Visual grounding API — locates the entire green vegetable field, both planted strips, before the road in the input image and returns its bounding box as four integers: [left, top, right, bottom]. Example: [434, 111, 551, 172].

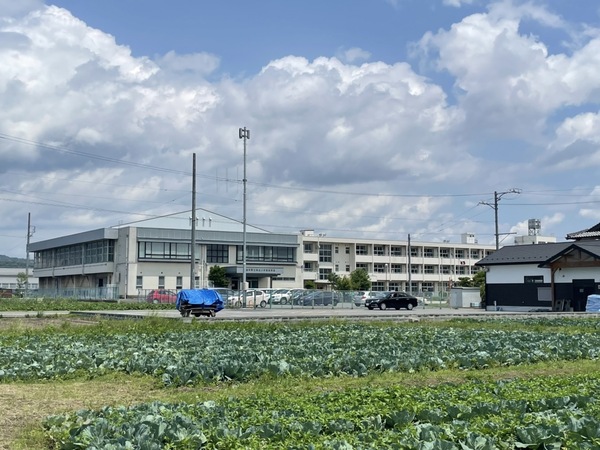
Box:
[0, 318, 600, 450]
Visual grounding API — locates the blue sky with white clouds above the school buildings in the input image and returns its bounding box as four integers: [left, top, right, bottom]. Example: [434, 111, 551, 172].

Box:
[0, 0, 600, 257]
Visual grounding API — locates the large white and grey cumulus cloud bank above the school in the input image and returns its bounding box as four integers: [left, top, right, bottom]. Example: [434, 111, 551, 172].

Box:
[0, 0, 600, 254]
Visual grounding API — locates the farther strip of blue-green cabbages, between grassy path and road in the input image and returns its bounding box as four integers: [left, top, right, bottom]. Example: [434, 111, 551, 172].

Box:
[0, 323, 600, 385]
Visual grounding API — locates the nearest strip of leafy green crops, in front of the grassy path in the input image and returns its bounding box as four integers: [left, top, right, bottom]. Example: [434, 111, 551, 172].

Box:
[44, 375, 600, 450]
